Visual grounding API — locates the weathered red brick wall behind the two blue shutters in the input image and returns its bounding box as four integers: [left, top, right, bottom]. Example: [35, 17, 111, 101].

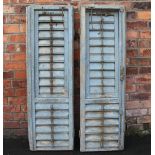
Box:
[3, 0, 151, 136]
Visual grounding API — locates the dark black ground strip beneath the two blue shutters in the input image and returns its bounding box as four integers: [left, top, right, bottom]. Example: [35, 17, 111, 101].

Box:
[3, 135, 151, 155]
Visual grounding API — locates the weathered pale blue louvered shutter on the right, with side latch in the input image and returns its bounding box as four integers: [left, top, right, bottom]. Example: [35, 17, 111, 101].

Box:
[80, 5, 125, 151]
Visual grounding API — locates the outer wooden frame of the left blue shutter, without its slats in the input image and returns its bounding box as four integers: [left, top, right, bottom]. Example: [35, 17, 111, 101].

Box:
[26, 5, 74, 151]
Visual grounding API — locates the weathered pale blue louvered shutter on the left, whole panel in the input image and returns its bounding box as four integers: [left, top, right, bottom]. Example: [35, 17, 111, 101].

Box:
[27, 5, 73, 150]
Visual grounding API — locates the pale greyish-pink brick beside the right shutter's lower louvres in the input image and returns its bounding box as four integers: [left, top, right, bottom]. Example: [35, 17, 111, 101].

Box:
[126, 109, 147, 117]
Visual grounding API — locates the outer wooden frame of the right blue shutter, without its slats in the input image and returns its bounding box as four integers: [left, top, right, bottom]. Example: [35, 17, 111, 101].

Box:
[80, 4, 126, 152]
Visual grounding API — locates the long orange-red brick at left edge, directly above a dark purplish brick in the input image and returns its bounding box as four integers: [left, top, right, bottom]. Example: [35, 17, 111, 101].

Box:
[4, 62, 26, 70]
